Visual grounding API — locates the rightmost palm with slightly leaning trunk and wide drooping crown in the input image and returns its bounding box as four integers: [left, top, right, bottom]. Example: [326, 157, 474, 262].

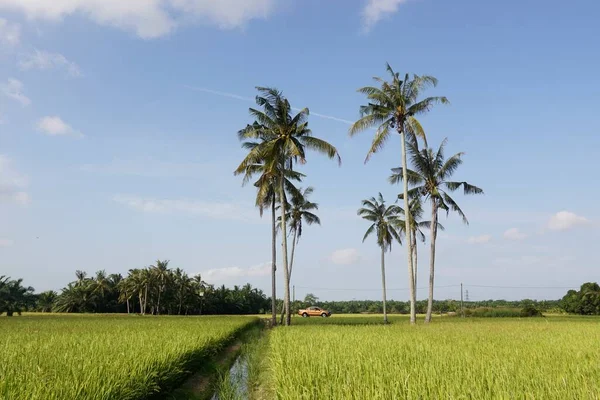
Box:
[390, 139, 483, 322]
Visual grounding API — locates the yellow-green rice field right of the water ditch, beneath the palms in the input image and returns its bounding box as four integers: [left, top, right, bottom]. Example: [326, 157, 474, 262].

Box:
[269, 316, 600, 400]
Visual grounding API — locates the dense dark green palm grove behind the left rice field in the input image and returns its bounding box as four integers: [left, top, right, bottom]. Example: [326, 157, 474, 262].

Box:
[0, 260, 270, 316]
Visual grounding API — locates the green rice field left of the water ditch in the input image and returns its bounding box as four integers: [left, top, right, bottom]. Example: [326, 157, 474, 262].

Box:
[0, 315, 257, 400]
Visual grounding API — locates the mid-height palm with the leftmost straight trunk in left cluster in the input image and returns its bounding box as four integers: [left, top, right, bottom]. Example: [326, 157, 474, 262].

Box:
[234, 155, 304, 326]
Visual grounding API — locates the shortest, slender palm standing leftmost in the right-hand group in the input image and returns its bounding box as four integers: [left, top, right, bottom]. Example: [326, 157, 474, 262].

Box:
[358, 193, 401, 324]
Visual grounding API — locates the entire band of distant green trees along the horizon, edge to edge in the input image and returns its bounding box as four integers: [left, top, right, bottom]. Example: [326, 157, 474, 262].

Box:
[0, 274, 600, 316]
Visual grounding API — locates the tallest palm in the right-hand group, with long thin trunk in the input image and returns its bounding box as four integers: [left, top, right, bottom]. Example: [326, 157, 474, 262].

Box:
[349, 64, 448, 324]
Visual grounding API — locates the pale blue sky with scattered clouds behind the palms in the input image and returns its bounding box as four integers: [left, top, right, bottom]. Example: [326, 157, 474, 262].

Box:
[0, 0, 600, 300]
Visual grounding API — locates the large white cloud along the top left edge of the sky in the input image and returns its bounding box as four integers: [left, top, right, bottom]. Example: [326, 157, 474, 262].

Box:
[0, 0, 276, 39]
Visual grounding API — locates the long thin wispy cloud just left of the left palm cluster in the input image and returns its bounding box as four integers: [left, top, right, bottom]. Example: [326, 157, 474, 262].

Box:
[113, 195, 259, 221]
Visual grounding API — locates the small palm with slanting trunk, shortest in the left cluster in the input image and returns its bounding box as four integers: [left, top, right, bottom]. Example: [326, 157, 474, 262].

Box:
[281, 186, 321, 320]
